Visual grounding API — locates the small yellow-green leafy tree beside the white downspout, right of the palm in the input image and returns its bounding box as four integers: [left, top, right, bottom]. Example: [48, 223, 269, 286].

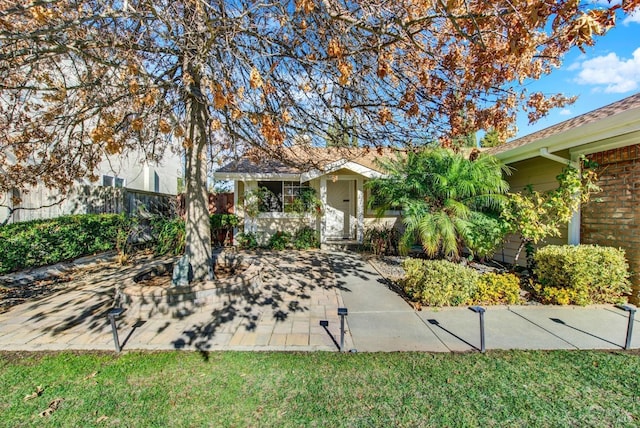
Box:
[502, 166, 600, 264]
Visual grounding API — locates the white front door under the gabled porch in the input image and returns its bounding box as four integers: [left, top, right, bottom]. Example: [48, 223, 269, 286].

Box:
[325, 180, 354, 239]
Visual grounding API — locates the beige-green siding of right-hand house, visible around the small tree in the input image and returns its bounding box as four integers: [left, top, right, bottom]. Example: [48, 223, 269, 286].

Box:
[494, 154, 568, 266]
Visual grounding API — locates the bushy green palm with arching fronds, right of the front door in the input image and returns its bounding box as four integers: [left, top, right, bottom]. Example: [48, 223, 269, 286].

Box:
[369, 148, 509, 259]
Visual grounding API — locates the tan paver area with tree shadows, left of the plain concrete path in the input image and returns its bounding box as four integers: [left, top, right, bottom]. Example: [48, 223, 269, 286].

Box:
[0, 251, 342, 351]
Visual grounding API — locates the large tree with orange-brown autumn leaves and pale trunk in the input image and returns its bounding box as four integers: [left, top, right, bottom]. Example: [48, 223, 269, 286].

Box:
[0, 0, 638, 278]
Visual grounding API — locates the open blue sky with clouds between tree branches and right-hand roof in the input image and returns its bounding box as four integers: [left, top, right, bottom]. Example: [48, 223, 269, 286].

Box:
[517, 5, 640, 137]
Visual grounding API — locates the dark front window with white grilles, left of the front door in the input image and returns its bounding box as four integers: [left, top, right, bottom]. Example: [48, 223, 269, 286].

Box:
[258, 181, 313, 213]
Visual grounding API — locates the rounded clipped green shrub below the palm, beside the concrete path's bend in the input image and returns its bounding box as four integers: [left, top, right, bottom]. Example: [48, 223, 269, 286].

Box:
[400, 259, 479, 306]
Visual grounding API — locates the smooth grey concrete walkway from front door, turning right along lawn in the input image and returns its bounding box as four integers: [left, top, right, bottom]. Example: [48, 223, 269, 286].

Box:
[331, 254, 640, 352]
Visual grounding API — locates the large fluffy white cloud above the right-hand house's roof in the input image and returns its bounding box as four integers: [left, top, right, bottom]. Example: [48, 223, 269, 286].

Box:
[572, 48, 640, 94]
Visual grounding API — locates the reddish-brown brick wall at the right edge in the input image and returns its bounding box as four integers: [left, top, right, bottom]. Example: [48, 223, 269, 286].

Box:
[580, 144, 640, 304]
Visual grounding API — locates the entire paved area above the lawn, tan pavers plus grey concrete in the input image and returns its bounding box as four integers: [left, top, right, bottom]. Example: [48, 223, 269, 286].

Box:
[0, 251, 640, 352]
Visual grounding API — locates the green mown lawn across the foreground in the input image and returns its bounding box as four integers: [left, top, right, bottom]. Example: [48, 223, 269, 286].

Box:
[0, 351, 640, 427]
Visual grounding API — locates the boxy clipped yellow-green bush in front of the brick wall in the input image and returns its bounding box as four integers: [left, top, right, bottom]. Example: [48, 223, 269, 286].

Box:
[534, 245, 631, 305]
